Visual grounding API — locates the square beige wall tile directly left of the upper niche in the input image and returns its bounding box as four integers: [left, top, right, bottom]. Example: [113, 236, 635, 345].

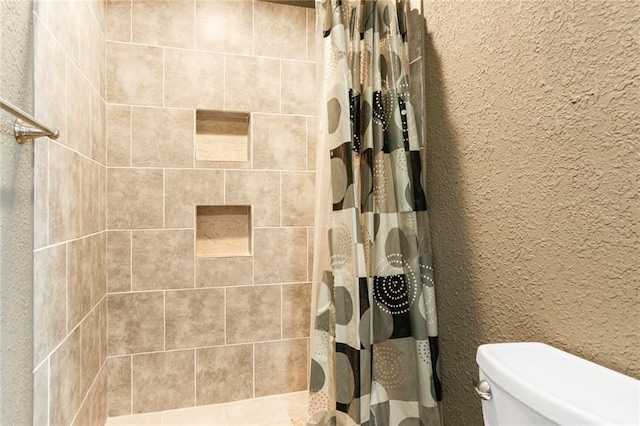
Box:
[131, 107, 194, 167]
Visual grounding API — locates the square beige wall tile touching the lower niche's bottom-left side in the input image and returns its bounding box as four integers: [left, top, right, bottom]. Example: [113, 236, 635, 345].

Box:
[132, 230, 195, 290]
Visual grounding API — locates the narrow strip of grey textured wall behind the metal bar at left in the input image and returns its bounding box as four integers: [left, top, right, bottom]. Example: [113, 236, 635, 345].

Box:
[0, 0, 33, 425]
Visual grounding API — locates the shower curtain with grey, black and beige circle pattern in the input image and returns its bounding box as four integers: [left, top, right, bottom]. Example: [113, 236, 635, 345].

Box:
[307, 0, 441, 426]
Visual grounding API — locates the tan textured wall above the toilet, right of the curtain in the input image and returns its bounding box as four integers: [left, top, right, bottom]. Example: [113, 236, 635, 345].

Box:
[424, 0, 640, 425]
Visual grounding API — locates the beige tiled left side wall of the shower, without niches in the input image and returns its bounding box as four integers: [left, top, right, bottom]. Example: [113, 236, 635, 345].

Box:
[33, 0, 107, 425]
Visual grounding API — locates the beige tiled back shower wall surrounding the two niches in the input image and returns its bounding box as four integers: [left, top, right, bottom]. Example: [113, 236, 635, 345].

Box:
[106, 0, 316, 416]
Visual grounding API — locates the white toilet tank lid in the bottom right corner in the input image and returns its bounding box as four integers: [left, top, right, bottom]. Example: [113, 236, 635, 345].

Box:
[476, 342, 640, 426]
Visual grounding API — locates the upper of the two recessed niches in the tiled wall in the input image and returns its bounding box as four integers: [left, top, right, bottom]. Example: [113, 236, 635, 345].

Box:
[196, 110, 249, 162]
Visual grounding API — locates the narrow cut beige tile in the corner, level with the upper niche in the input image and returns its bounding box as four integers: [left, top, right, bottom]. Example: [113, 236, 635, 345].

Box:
[107, 105, 131, 166]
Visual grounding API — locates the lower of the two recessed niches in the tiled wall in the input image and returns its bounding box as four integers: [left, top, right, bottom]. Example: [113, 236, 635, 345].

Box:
[196, 206, 251, 257]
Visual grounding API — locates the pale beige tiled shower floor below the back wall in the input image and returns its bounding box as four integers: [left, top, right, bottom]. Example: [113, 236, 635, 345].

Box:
[106, 391, 307, 426]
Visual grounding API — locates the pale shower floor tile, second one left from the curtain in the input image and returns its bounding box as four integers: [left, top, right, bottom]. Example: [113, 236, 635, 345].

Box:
[224, 397, 288, 426]
